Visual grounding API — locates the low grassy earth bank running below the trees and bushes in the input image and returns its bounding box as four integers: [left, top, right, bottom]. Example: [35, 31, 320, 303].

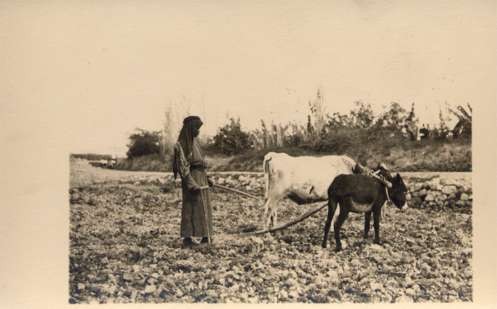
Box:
[110, 140, 472, 172]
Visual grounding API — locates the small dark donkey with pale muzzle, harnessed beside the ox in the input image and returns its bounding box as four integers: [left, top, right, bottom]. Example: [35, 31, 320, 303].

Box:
[322, 169, 407, 251]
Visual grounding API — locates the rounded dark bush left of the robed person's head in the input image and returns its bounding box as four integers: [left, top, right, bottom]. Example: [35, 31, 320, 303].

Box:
[126, 128, 162, 159]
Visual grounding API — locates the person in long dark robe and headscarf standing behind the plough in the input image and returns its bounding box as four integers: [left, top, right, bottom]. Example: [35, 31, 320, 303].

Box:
[173, 116, 212, 248]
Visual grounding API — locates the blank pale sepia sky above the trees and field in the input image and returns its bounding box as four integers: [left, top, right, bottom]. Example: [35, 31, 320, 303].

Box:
[0, 0, 497, 155]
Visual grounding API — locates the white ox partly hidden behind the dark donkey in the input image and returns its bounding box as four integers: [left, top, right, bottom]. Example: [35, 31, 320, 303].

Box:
[263, 152, 356, 228]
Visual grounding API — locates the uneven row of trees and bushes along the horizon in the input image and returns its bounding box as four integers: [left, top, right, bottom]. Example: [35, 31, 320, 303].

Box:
[118, 90, 472, 160]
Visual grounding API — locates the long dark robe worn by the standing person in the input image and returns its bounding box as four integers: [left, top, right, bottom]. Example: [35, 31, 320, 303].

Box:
[174, 138, 212, 237]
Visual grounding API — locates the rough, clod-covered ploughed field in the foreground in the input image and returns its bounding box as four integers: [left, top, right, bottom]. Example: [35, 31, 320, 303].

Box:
[69, 161, 473, 303]
